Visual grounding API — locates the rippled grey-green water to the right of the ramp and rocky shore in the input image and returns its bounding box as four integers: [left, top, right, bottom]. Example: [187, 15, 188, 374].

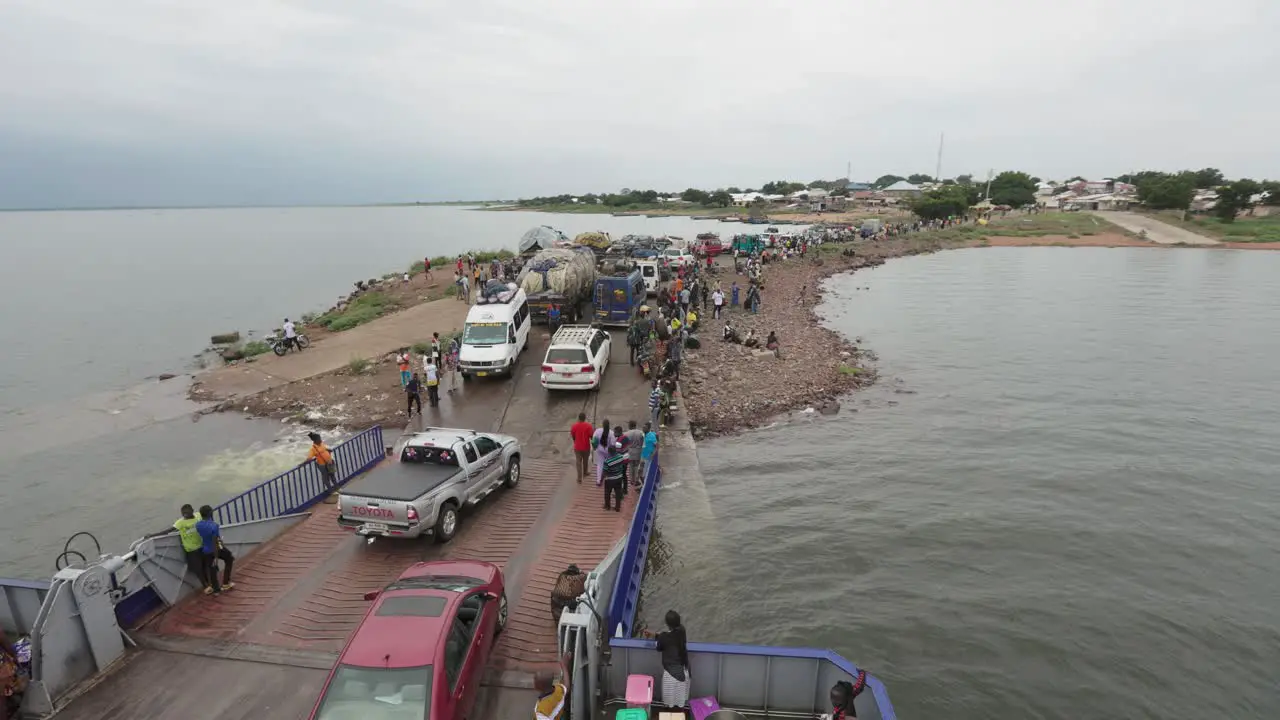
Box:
[643, 247, 1280, 720]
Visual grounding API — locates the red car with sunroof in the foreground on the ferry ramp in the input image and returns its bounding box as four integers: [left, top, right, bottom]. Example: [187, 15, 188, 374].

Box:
[311, 561, 507, 720]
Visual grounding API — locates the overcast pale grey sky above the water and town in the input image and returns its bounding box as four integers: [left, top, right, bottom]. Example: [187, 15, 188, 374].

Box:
[0, 0, 1280, 208]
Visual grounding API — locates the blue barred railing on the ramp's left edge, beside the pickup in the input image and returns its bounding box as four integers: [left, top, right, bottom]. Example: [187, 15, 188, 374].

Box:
[214, 425, 387, 525]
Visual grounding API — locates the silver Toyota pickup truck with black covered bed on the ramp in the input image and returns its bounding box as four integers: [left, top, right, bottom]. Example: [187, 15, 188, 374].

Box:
[338, 428, 521, 542]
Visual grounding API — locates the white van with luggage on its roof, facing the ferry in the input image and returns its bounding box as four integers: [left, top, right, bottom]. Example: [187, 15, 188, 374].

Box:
[458, 283, 530, 380]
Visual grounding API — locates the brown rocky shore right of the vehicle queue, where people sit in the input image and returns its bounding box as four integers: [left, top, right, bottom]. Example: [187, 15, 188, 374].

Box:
[681, 233, 972, 438]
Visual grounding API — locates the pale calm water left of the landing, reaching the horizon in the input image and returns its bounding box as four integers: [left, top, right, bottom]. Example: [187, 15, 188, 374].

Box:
[0, 206, 741, 579]
